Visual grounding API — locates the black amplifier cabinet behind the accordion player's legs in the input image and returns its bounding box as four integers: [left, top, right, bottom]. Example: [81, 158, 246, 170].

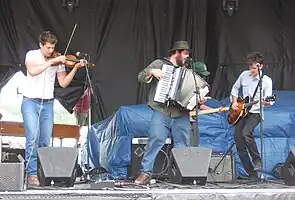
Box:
[128, 138, 172, 180]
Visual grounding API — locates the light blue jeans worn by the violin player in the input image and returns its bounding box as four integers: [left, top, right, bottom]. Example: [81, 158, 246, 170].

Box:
[21, 97, 53, 176]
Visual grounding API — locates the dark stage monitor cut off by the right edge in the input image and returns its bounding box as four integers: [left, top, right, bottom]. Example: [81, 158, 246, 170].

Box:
[282, 148, 295, 186]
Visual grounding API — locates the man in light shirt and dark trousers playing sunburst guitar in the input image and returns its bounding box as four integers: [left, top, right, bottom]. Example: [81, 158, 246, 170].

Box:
[231, 53, 272, 179]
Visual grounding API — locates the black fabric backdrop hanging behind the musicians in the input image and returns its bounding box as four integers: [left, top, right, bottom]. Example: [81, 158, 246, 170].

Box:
[0, 0, 295, 122]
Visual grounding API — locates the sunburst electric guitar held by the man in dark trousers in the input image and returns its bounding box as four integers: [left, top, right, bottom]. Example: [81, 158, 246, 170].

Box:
[227, 95, 276, 125]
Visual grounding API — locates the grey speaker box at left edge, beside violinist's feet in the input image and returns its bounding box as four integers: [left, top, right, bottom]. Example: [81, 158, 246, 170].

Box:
[0, 162, 25, 192]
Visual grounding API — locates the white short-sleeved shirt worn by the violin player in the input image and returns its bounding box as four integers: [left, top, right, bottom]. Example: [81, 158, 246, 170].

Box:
[23, 49, 65, 99]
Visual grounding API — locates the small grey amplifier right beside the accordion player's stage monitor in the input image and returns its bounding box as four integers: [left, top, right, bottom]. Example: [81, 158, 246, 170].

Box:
[207, 152, 236, 183]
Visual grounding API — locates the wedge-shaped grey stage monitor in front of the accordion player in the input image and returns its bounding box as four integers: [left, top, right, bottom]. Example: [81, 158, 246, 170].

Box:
[169, 147, 212, 185]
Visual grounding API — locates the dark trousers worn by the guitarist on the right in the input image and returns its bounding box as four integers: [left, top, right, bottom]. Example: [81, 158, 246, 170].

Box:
[234, 113, 261, 174]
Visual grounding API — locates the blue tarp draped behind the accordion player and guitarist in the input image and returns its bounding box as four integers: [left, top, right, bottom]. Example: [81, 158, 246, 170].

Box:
[82, 91, 295, 179]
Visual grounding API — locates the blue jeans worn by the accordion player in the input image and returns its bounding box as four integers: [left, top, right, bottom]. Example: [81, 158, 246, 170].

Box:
[141, 110, 190, 175]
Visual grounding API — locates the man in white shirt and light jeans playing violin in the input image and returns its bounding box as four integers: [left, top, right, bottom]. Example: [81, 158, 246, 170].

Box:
[21, 31, 85, 187]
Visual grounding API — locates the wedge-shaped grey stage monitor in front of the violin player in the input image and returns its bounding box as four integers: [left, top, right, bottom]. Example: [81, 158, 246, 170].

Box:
[38, 147, 78, 187]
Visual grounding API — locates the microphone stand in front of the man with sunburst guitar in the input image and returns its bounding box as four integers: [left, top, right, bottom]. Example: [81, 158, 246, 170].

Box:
[258, 66, 265, 182]
